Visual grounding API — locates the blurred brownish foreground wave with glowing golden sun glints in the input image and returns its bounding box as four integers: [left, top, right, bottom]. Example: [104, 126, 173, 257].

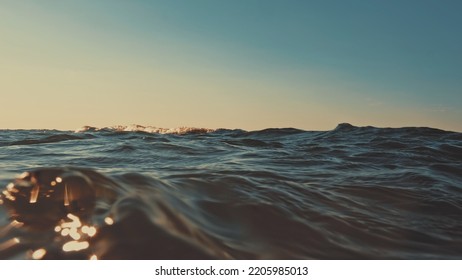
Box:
[0, 167, 220, 259]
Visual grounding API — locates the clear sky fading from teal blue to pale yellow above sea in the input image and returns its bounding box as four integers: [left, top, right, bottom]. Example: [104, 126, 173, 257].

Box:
[0, 0, 462, 131]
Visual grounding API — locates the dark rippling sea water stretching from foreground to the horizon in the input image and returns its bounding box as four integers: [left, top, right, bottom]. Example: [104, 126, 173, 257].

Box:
[0, 124, 462, 259]
